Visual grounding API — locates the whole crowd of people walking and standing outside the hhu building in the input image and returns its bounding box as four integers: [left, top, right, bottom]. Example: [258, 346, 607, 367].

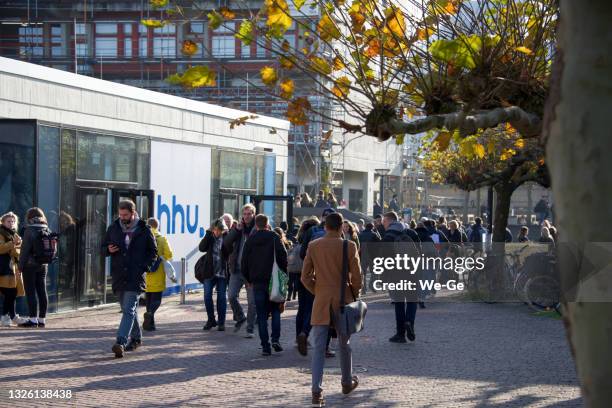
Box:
[0, 197, 557, 404]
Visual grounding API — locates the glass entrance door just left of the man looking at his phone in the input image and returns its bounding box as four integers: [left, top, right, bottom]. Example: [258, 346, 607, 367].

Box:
[76, 188, 108, 307]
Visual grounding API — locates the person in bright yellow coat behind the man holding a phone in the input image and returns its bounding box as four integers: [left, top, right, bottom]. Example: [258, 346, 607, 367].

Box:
[142, 218, 176, 331]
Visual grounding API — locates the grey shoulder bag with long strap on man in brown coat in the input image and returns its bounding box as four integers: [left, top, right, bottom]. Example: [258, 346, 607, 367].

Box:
[334, 240, 368, 337]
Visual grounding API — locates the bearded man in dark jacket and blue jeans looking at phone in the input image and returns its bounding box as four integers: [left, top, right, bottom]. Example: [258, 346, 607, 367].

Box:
[102, 200, 157, 358]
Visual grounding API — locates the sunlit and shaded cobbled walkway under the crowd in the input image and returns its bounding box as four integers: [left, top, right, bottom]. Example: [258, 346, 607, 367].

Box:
[0, 294, 582, 407]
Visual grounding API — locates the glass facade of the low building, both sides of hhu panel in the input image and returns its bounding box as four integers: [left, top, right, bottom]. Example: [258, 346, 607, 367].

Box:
[0, 119, 284, 313]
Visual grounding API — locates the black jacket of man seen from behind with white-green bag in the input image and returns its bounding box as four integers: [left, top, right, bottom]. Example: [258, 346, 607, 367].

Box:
[241, 230, 287, 290]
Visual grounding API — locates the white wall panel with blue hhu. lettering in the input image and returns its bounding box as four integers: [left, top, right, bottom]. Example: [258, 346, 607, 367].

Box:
[151, 141, 211, 292]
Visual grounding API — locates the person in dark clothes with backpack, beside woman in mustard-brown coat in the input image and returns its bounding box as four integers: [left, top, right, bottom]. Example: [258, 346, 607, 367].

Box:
[19, 207, 57, 327]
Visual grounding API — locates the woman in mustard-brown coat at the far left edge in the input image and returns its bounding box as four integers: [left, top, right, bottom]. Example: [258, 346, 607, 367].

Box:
[0, 212, 25, 326]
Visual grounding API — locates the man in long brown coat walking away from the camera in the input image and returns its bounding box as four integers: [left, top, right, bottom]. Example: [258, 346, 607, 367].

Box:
[301, 213, 361, 406]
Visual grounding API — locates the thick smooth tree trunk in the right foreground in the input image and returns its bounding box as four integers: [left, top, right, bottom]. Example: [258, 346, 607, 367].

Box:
[544, 0, 612, 407]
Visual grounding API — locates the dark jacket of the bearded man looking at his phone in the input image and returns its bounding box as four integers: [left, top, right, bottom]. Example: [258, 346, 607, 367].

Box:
[102, 219, 157, 293]
